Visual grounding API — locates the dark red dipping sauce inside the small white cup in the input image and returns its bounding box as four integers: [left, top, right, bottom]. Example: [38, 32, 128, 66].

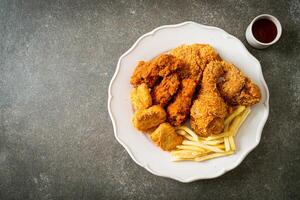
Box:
[252, 19, 277, 43]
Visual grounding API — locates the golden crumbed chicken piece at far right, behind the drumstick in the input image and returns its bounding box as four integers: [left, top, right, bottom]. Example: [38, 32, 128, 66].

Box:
[218, 61, 261, 106]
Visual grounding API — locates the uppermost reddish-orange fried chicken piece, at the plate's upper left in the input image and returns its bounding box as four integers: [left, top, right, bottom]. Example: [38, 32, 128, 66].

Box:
[130, 54, 183, 88]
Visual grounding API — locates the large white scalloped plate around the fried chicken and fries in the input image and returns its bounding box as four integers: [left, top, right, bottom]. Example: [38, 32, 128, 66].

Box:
[108, 22, 269, 182]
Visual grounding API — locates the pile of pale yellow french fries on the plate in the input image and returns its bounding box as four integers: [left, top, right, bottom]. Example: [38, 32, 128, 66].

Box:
[171, 106, 250, 162]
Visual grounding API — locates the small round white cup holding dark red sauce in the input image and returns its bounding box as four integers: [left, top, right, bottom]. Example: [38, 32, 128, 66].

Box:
[246, 14, 282, 49]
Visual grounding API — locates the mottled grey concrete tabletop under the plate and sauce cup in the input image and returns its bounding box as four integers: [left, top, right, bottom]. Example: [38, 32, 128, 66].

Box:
[0, 0, 300, 200]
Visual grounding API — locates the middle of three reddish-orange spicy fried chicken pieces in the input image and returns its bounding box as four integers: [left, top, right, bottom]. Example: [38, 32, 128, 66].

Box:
[151, 73, 180, 107]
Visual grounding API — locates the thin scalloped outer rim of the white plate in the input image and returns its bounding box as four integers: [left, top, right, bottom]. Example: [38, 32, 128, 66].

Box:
[107, 21, 270, 183]
